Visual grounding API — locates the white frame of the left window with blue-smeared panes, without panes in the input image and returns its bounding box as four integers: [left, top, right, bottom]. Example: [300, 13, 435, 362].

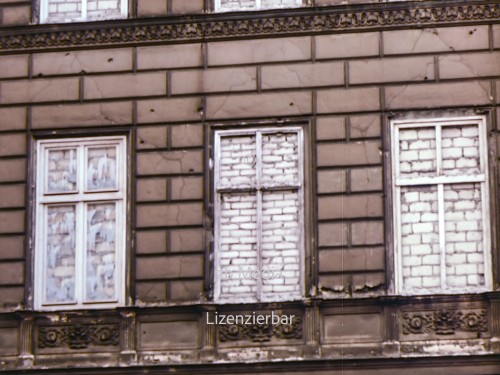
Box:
[33, 136, 127, 311]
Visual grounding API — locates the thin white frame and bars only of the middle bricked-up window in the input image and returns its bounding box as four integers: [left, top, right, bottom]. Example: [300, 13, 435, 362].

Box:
[214, 127, 305, 303]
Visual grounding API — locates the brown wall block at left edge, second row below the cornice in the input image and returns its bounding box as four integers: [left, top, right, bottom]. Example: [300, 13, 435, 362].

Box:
[0, 78, 80, 104]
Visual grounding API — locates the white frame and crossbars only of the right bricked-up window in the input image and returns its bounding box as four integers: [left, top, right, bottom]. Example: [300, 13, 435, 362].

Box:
[391, 116, 493, 295]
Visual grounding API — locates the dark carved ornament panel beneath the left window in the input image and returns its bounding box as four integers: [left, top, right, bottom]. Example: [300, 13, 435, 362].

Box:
[38, 324, 120, 349]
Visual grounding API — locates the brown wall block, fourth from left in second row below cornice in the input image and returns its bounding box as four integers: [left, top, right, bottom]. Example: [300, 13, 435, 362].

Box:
[262, 62, 344, 90]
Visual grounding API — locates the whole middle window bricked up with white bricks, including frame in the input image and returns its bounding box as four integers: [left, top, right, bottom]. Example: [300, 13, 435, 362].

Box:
[214, 128, 304, 302]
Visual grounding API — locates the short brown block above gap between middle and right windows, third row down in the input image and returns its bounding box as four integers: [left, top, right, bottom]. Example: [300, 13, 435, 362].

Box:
[317, 87, 380, 113]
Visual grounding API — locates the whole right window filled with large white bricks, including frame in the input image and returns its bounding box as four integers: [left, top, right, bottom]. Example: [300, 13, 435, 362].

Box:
[392, 117, 492, 294]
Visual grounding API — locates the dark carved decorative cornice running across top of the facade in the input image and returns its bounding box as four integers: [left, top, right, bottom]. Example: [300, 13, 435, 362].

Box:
[0, 0, 500, 52]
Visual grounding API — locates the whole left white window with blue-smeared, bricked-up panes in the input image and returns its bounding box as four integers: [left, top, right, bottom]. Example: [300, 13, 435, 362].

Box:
[34, 136, 127, 310]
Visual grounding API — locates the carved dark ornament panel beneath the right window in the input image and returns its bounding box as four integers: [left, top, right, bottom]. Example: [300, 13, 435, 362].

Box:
[402, 310, 488, 335]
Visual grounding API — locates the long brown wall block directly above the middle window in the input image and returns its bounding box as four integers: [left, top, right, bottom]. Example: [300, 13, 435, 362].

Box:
[207, 92, 312, 119]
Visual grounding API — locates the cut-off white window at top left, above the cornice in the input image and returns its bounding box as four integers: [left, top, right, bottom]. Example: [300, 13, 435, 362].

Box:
[40, 0, 128, 23]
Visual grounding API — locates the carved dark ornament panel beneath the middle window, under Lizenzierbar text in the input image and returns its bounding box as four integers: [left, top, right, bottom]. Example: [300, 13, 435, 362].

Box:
[217, 317, 302, 342]
